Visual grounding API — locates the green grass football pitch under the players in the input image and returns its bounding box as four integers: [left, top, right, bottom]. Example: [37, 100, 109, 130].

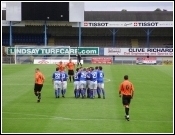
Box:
[1, 64, 174, 133]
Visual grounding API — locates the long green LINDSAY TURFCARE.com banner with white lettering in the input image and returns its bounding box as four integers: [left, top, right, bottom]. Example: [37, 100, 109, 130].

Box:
[7, 46, 99, 55]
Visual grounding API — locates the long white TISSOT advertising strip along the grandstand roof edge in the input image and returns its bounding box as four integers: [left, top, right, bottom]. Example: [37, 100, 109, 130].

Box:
[76, 21, 173, 28]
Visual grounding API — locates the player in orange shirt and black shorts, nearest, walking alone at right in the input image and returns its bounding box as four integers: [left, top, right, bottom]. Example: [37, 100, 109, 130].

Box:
[119, 75, 134, 121]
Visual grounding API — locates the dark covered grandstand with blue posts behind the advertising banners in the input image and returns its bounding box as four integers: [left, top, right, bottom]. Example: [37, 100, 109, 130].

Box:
[2, 2, 173, 64]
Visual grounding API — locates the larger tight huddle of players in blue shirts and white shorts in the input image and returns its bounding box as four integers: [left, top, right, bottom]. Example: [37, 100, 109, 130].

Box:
[74, 66, 105, 99]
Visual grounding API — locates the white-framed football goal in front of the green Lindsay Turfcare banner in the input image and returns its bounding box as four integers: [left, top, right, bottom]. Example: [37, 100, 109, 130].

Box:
[11, 45, 70, 64]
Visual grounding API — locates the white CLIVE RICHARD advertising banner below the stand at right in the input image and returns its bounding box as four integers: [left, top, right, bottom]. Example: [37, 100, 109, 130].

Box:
[104, 48, 173, 56]
